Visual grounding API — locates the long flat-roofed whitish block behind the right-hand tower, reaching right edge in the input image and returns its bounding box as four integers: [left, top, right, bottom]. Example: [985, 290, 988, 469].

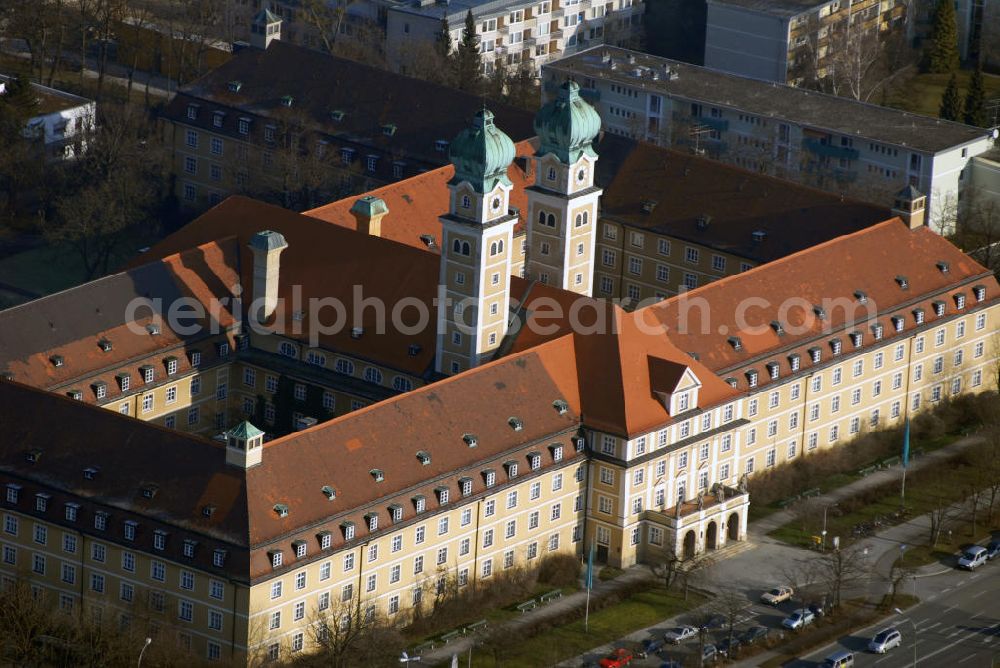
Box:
[543, 47, 995, 234]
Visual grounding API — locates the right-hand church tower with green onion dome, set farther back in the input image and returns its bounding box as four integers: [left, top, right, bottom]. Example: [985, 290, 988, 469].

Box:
[526, 81, 602, 296]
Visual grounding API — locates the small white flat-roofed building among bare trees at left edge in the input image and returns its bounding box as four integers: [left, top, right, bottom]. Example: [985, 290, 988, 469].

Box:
[0, 74, 97, 162]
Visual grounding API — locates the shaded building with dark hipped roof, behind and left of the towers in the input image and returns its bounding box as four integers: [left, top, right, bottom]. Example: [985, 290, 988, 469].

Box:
[162, 35, 532, 210]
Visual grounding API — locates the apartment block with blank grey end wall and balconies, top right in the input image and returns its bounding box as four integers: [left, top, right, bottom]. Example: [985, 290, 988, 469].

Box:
[705, 0, 909, 85]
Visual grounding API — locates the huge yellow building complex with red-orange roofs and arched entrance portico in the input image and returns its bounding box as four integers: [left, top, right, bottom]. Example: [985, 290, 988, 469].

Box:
[0, 86, 1000, 661]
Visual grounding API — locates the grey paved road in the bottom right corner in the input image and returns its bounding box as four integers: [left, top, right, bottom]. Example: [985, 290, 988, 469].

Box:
[789, 559, 1000, 668]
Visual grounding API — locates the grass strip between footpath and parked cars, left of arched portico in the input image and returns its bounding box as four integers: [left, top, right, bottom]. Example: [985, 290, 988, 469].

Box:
[462, 586, 704, 668]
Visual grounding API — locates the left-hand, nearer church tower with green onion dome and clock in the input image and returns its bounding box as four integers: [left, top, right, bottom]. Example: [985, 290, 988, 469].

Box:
[435, 108, 517, 374]
